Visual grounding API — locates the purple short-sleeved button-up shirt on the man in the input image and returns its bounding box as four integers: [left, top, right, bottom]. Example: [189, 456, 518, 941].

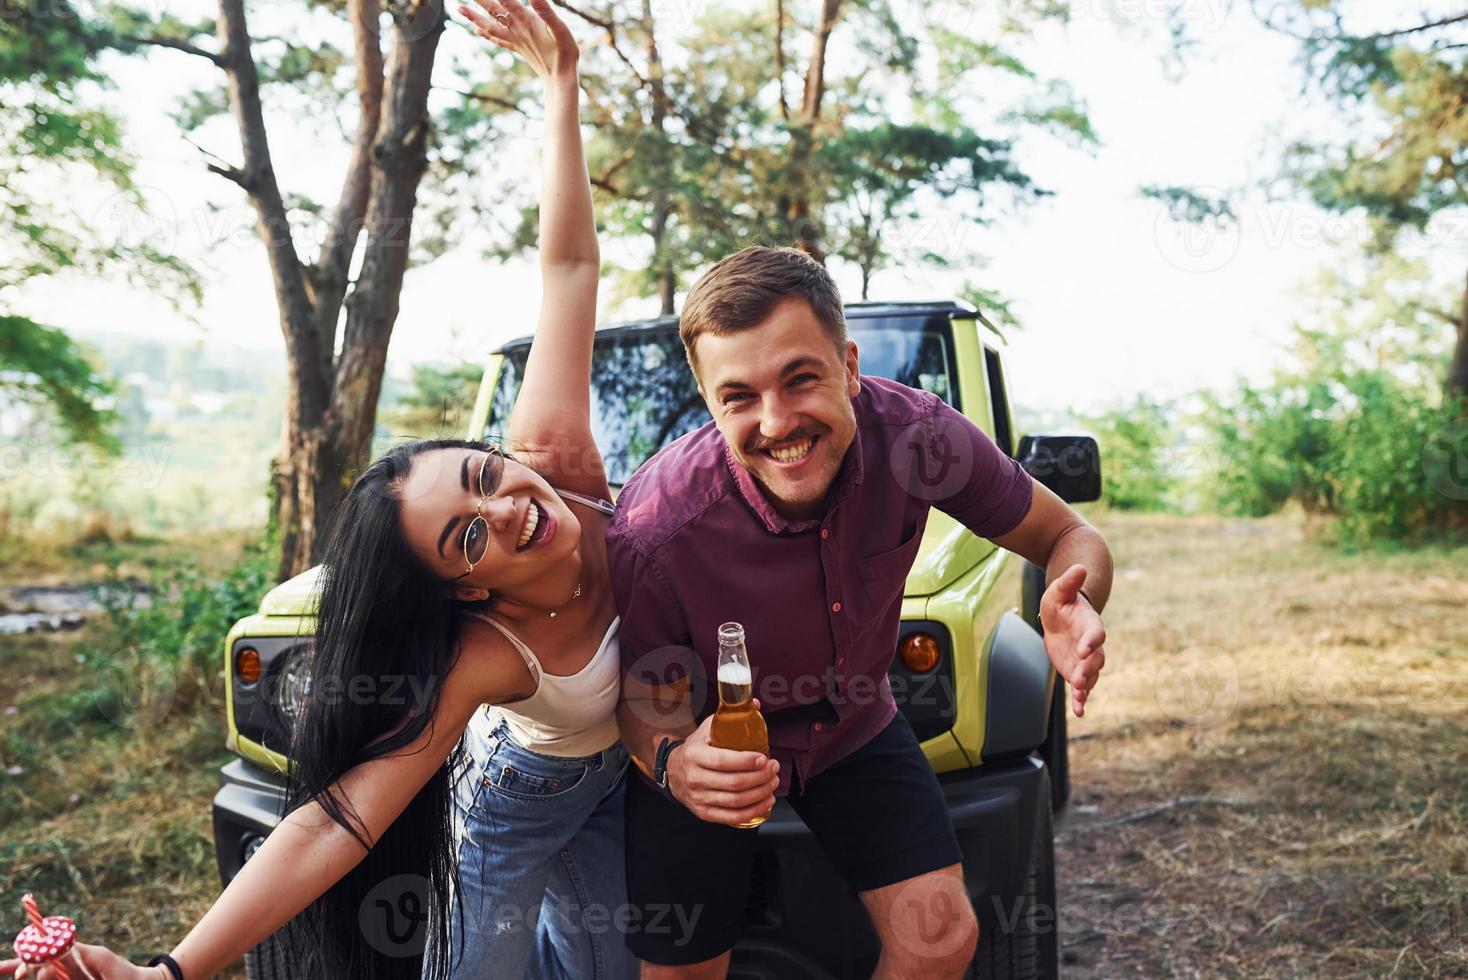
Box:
[606, 377, 1032, 795]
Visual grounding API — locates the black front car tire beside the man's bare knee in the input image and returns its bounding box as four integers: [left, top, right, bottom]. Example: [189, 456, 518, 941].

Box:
[969, 801, 1060, 980]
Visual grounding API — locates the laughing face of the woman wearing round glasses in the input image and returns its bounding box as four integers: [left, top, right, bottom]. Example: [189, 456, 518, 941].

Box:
[398, 449, 581, 600]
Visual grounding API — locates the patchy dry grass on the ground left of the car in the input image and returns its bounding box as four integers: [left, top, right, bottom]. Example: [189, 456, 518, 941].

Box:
[0, 538, 244, 979]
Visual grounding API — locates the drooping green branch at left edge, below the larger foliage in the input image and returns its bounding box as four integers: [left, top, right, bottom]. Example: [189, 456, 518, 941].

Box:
[0, 315, 119, 453]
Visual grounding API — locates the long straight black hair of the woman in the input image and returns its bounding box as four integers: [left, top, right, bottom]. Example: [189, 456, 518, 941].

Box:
[283, 439, 492, 980]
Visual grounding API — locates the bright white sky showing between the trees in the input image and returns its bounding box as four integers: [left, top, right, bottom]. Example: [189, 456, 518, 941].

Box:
[25, 0, 1468, 411]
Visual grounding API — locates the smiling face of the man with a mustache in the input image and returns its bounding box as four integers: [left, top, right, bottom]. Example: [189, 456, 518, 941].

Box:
[694, 299, 860, 521]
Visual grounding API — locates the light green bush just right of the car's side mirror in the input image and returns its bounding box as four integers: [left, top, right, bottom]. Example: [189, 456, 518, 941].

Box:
[1086, 395, 1177, 511]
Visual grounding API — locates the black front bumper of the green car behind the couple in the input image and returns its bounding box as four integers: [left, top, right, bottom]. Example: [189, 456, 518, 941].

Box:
[214, 756, 1050, 980]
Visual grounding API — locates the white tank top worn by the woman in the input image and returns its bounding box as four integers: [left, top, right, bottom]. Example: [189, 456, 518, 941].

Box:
[470, 613, 622, 756]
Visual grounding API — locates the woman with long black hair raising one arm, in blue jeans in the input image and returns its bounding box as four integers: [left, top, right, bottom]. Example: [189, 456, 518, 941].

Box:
[0, 0, 636, 980]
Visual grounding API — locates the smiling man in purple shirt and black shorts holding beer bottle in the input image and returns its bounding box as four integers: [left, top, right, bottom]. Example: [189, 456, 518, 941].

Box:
[608, 246, 1111, 977]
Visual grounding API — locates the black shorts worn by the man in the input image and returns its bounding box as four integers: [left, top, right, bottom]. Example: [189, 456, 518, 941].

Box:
[627, 712, 963, 965]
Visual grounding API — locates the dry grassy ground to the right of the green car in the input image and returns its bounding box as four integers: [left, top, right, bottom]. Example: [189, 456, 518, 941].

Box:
[1057, 516, 1468, 977]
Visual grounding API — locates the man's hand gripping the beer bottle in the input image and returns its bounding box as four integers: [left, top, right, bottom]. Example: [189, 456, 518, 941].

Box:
[668, 698, 780, 826]
